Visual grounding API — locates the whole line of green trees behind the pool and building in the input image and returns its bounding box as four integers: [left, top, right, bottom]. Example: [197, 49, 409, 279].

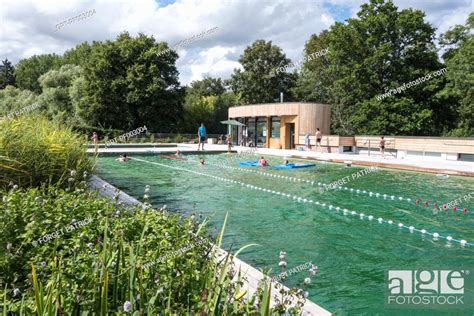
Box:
[0, 0, 474, 136]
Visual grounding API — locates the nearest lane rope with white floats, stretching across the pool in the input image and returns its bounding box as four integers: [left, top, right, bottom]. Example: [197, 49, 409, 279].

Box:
[133, 158, 474, 246]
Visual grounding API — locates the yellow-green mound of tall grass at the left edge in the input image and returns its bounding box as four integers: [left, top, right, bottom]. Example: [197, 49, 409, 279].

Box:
[0, 115, 92, 187]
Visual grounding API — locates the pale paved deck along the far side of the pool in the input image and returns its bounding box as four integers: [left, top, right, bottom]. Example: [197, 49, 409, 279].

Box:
[87, 144, 474, 177]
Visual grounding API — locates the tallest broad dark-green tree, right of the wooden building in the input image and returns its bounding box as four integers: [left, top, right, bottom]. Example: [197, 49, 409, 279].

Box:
[326, 0, 453, 135]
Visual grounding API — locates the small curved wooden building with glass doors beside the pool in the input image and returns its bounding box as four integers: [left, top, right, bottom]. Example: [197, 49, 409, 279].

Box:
[229, 102, 331, 149]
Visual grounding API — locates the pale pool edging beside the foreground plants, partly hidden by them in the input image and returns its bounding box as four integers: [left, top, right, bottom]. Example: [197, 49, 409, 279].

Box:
[89, 175, 333, 316]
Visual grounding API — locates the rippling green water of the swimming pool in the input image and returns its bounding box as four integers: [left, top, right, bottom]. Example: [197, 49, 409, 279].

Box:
[98, 154, 474, 315]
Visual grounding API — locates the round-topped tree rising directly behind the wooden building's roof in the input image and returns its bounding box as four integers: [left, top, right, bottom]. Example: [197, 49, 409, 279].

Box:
[230, 40, 296, 103]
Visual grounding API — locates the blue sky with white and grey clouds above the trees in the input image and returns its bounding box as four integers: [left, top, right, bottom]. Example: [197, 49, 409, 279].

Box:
[0, 0, 474, 85]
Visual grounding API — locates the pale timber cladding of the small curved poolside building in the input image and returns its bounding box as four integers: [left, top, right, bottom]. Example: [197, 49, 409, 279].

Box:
[229, 102, 331, 149]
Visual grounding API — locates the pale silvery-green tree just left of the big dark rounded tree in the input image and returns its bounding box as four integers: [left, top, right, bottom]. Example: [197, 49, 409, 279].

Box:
[39, 65, 83, 125]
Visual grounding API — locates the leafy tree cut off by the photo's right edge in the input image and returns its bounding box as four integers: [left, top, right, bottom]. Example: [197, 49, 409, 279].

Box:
[440, 12, 474, 136]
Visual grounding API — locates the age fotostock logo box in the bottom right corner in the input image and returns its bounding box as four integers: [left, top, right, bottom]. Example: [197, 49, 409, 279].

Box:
[385, 269, 473, 309]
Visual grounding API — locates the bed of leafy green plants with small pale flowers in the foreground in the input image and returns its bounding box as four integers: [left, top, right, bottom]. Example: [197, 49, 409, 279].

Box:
[0, 184, 304, 315]
